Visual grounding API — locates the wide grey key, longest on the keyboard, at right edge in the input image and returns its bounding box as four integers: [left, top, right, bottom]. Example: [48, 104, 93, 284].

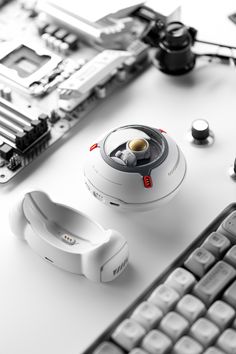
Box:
[193, 261, 236, 305]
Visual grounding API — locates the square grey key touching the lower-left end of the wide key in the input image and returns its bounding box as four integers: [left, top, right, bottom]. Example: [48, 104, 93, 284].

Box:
[176, 294, 206, 324]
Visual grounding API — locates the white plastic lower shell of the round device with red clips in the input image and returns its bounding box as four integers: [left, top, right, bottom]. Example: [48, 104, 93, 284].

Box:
[84, 128, 186, 211]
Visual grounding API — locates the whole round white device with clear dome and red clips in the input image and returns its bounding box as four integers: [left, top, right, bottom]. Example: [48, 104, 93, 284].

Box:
[84, 125, 186, 210]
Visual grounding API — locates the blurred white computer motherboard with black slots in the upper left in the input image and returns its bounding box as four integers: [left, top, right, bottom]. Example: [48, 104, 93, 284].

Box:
[0, 0, 179, 183]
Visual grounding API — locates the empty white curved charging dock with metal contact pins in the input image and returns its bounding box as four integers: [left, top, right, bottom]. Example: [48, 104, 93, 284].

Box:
[10, 191, 128, 282]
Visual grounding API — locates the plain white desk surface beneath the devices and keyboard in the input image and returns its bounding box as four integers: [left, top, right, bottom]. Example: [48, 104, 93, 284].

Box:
[0, 0, 236, 354]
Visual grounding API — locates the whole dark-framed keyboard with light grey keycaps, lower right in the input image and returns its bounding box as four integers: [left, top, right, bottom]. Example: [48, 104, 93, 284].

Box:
[84, 204, 236, 354]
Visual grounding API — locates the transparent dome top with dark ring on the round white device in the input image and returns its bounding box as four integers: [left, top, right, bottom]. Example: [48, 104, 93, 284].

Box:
[100, 125, 168, 172]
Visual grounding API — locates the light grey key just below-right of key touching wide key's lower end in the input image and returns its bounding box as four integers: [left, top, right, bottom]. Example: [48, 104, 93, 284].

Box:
[190, 318, 220, 347]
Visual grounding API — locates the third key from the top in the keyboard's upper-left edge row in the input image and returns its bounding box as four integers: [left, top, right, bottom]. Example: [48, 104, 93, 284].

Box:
[184, 247, 215, 277]
